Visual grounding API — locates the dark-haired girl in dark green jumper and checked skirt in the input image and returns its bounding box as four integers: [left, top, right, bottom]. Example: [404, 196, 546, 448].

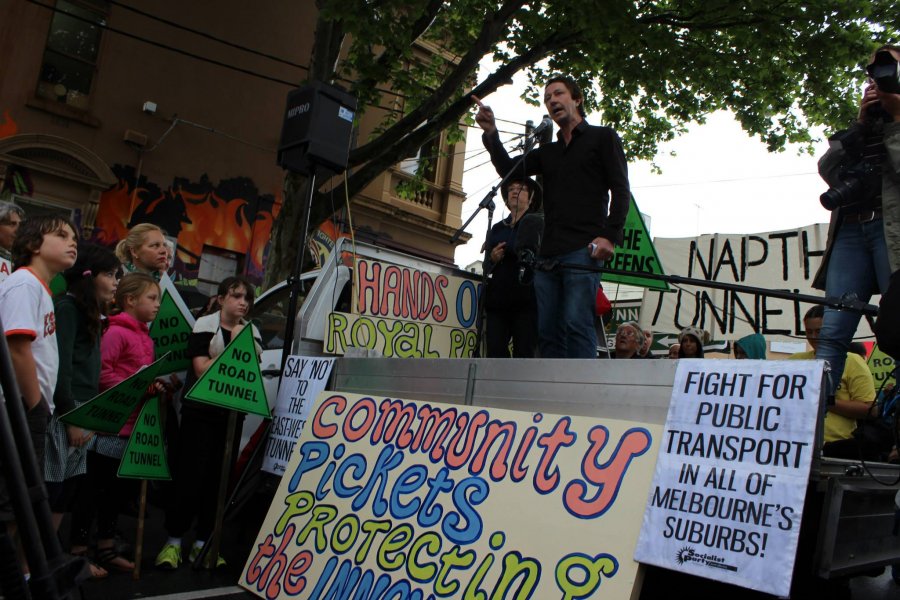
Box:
[43, 244, 121, 578]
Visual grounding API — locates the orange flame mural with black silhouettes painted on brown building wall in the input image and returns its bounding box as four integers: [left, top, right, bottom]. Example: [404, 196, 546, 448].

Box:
[93, 165, 281, 283]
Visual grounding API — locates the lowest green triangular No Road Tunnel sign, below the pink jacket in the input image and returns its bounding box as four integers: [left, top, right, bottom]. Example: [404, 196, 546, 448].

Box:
[119, 396, 172, 479]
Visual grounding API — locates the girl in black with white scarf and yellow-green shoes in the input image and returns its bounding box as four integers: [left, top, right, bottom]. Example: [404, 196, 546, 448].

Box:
[156, 277, 262, 569]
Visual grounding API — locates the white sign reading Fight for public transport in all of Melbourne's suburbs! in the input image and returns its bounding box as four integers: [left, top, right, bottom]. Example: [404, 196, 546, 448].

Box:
[634, 360, 824, 596]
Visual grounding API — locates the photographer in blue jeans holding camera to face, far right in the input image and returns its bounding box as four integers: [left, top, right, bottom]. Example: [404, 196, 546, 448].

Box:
[813, 46, 900, 396]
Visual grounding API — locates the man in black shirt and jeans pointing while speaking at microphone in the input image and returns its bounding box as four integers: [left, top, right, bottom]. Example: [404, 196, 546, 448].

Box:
[472, 76, 631, 358]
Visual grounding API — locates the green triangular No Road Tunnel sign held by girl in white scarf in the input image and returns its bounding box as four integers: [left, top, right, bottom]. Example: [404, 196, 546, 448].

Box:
[187, 325, 271, 419]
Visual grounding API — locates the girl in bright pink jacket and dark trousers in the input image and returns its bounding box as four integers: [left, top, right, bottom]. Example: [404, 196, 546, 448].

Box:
[72, 273, 163, 572]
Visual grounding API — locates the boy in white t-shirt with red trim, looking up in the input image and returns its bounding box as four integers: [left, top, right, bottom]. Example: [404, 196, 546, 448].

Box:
[0, 216, 78, 521]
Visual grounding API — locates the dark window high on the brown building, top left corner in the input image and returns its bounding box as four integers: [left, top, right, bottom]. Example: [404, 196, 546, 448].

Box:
[37, 0, 109, 110]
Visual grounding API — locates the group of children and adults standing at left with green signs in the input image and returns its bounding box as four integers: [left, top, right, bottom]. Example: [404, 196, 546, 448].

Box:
[0, 211, 261, 579]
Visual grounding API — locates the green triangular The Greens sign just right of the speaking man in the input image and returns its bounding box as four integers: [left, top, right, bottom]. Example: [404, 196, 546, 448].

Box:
[603, 196, 669, 292]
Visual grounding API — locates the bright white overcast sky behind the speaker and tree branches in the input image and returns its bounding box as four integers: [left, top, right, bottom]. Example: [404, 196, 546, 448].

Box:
[456, 68, 829, 267]
